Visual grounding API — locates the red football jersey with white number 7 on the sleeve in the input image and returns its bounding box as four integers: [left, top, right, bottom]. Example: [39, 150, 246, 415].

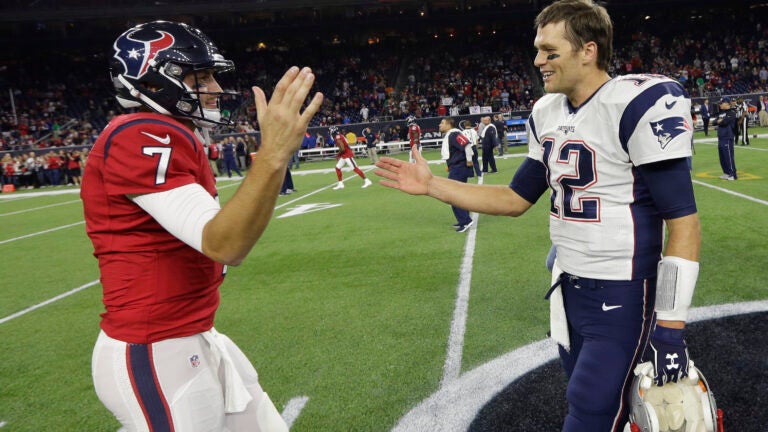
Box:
[80, 113, 224, 343]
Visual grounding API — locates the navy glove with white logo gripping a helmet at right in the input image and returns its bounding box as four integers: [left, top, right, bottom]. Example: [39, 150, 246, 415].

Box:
[643, 324, 689, 386]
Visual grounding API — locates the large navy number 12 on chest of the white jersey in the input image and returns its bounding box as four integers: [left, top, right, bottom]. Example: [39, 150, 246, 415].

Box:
[542, 138, 601, 222]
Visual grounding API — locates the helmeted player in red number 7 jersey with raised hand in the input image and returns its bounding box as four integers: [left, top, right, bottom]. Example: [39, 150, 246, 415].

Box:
[81, 21, 323, 432]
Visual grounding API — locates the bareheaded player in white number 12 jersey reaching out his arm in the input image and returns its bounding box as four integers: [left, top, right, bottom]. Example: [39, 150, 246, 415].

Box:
[376, 0, 700, 432]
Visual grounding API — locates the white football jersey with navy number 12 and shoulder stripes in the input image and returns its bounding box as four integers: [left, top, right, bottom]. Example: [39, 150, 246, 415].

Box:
[528, 75, 693, 280]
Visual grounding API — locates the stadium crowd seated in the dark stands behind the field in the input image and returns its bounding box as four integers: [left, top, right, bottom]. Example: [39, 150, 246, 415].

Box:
[0, 2, 768, 187]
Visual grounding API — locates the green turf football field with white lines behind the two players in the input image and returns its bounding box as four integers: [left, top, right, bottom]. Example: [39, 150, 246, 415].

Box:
[0, 129, 768, 432]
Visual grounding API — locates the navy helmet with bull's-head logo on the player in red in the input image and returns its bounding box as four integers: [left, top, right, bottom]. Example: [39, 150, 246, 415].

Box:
[109, 21, 234, 128]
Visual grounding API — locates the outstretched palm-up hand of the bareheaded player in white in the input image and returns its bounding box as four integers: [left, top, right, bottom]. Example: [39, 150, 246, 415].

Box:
[374, 151, 432, 195]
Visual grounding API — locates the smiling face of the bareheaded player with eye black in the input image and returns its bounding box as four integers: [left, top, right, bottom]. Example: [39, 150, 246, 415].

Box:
[533, 21, 582, 96]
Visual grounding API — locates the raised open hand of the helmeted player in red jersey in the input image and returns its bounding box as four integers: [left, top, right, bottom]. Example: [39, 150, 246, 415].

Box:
[252, 66, 323, 163]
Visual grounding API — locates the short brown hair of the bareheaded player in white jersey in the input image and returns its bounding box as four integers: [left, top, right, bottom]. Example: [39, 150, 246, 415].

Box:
[534, 0, 613, 71]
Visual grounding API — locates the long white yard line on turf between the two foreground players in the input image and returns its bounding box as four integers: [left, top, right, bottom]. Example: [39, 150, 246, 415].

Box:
[440, 177, 483, 388]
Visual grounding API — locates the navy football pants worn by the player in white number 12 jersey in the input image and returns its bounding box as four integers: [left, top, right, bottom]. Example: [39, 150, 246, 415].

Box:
[559, 273, 656, 432]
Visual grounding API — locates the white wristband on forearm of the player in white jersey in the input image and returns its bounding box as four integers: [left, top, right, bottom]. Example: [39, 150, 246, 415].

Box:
[656, 256, 699, 321]
